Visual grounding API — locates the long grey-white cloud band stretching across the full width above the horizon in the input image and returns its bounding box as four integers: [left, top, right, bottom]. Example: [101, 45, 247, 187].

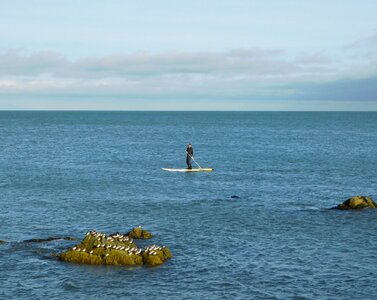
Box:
[0, 45, 377, 106]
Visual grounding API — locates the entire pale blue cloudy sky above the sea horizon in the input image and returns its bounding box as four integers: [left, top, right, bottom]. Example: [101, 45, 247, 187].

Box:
[0, 0, 377, 111]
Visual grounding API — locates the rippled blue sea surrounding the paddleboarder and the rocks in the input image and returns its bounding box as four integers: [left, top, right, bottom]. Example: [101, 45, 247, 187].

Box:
[0, 111, 377, 299]
